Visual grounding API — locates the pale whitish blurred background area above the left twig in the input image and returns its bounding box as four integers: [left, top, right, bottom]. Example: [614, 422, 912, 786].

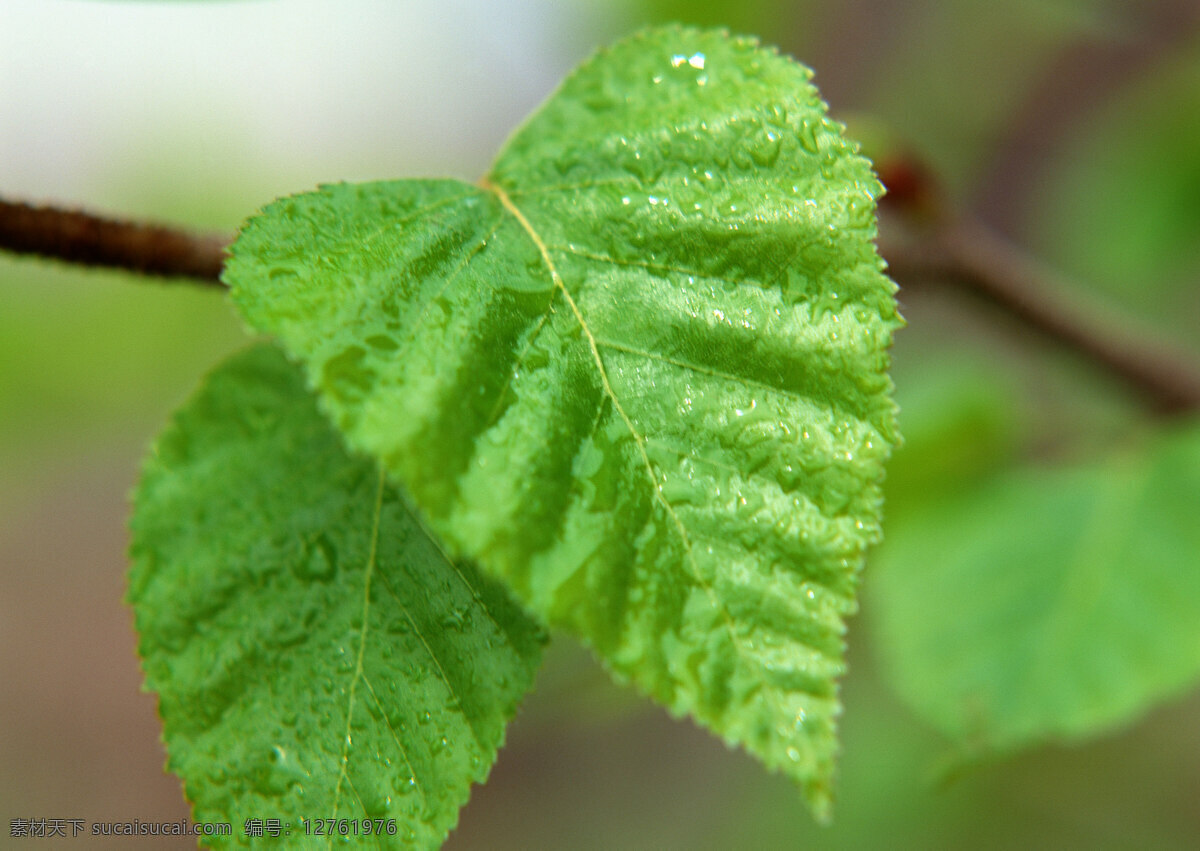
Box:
[0, 0, 609, 215]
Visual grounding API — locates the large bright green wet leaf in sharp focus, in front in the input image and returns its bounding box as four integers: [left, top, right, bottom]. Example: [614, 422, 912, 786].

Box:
[226, 29, 900, 814]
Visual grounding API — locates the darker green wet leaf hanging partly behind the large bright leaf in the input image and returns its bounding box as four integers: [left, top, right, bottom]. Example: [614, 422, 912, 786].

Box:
[128, 344, 541, 847]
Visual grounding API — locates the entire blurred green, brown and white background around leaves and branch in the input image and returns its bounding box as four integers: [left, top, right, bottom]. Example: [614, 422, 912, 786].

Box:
[0, 0, 1200, 850]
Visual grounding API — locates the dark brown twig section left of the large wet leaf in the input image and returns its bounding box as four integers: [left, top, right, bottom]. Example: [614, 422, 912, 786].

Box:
[0, 198, 229, 286]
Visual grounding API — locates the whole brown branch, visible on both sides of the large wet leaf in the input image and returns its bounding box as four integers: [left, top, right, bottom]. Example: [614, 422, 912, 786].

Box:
[0, 192, 1200, 414]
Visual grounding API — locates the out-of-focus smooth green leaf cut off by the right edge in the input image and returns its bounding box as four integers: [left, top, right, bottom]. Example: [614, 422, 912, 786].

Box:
[871, 425, 1200, 751]
